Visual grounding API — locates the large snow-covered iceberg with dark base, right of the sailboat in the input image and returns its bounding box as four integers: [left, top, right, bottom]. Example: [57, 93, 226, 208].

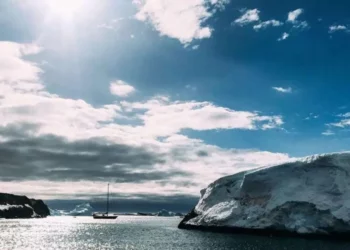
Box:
[179, 152, 350, 236]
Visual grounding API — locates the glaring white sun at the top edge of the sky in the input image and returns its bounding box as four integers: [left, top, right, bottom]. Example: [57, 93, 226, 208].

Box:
[47, 0, 88, 19]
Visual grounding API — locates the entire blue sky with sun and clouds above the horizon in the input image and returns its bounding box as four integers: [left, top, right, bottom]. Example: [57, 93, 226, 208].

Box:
[0, 0, 350, 209]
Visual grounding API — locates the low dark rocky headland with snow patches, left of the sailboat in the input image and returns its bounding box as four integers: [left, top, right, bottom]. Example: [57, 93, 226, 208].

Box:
[0, 193, 50, 219]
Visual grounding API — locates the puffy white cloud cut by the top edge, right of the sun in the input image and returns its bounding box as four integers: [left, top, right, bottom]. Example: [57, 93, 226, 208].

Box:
[133, 0, 228, 44]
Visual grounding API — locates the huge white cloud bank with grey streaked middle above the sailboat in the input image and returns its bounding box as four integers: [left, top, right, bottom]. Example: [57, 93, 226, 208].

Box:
[0, 43, 290, 199]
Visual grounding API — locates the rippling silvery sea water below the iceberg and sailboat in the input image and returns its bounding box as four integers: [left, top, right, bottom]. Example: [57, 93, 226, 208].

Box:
[0, 216, 350, 250]
